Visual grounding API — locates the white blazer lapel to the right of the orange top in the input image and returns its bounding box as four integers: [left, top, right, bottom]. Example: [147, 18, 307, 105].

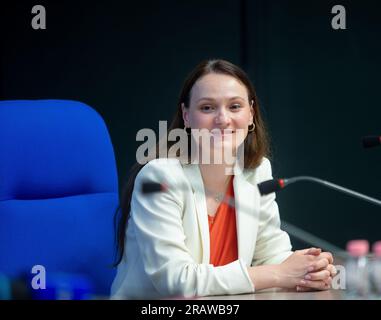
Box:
[234, 165, 260, 266]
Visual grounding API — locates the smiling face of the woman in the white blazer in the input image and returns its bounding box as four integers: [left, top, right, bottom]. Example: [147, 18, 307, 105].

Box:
[182, 73, 254, 161]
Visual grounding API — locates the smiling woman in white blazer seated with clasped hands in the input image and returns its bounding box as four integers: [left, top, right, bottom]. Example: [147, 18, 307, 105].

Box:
[111, 60, 335, 298]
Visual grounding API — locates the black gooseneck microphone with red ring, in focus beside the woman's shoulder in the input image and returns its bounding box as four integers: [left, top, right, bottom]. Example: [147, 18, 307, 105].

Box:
[258, 176, 381, 206]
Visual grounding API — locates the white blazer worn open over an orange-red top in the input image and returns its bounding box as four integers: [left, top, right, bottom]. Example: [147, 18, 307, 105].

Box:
[111, 158, 292, 299]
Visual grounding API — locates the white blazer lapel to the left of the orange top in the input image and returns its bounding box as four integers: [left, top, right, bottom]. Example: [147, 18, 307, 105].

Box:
[183, 164, 210, 263]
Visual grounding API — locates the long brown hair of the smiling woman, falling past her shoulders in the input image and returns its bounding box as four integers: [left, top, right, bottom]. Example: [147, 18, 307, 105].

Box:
[114, 60, 270, 266]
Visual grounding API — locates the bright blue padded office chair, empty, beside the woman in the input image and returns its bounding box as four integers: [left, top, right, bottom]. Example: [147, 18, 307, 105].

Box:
[0, 100, 118, 295]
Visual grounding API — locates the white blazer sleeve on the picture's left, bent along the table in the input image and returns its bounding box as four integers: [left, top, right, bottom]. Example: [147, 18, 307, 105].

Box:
[130, 160, 254, 297]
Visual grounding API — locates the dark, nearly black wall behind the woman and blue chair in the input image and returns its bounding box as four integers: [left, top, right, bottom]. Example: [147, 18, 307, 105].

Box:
[0, 0, 381, 252]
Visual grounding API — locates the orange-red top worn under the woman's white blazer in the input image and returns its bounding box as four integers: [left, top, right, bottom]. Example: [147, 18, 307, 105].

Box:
[208, 179, 238, 267]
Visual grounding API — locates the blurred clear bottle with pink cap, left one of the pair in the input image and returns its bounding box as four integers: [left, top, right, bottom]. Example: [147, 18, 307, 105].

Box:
[345, 240, 370, 299]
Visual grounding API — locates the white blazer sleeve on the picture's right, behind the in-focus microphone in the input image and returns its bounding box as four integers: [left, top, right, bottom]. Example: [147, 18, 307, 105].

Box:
[252, 158, 292, 266]
